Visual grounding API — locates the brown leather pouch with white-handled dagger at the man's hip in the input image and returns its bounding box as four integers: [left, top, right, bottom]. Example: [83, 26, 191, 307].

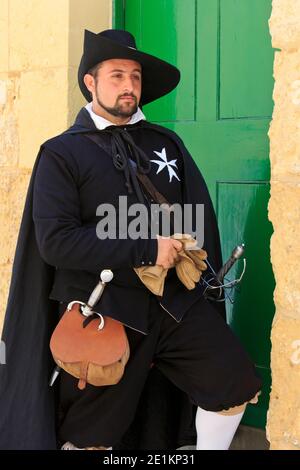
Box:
[50, 270, 130, 390]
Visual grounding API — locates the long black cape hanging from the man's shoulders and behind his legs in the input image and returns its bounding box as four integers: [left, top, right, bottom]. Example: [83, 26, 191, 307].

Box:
[0, 109, 221, 450]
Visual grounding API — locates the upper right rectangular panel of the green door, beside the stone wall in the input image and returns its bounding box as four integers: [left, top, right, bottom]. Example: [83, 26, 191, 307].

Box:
[220, 0, 273, 119]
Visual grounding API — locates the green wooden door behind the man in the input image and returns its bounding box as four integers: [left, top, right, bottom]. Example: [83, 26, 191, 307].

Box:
[115, 0, 274, 427]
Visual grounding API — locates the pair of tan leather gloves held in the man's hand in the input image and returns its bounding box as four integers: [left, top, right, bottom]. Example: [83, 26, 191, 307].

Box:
[134, 233, 207, 296]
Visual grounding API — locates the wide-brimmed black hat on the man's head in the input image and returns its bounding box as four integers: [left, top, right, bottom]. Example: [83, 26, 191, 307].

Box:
[78, 29, 180, 105]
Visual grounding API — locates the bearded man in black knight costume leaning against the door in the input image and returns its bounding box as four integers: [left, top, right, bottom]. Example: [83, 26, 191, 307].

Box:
[0, 30, 261, 449]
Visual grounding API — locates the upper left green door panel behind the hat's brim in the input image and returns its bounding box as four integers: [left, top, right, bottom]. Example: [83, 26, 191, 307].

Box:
[125, 0, 196, 122]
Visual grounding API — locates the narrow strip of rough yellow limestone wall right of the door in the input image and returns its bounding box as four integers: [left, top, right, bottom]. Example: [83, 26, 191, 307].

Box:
[268, 0, 300, 449]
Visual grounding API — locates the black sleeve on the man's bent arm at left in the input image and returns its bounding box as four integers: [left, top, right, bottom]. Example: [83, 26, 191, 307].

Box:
[33, 149, 157, 272]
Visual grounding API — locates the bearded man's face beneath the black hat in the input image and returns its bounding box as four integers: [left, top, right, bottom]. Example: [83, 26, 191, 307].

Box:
[85, 59, 142, 124]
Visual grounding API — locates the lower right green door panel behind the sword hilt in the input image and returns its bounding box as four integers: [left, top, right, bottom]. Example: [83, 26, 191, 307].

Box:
[217, 181, 274, 367]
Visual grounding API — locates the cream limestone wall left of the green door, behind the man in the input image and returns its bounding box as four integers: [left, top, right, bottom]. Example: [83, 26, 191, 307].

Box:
[0, 0, 112, 330]
